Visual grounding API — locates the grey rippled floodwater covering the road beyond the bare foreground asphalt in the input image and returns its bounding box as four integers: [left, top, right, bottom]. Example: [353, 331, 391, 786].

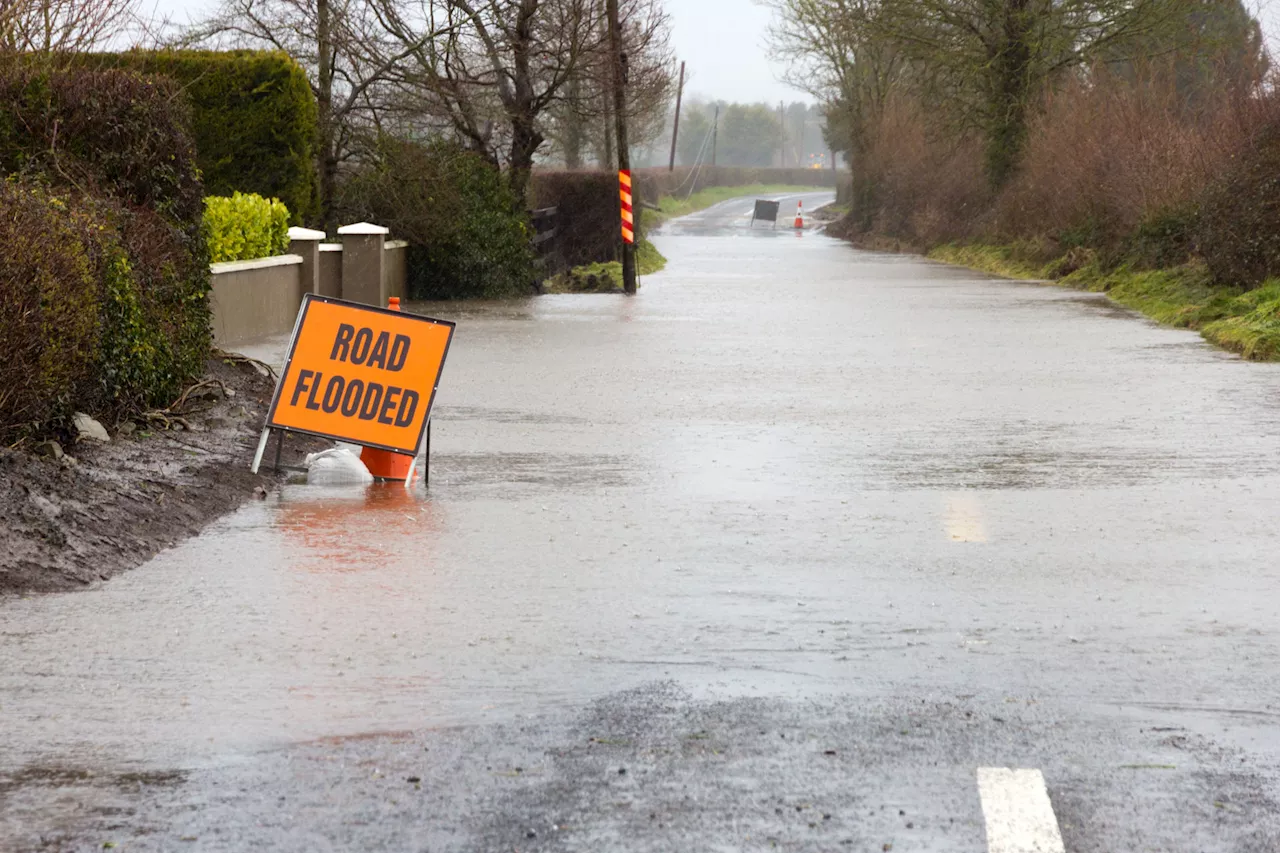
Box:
[0, 196, 1280, 845]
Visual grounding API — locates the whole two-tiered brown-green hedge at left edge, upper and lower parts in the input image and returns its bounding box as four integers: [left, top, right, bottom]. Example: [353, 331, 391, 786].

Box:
[0, 63, 210, 439]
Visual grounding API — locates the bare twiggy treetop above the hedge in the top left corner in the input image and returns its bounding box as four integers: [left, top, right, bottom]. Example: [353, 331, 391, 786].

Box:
[0, 0, 137, 54]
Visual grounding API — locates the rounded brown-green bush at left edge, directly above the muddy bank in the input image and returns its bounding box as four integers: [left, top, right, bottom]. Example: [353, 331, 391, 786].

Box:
[0, 181, 207, 441]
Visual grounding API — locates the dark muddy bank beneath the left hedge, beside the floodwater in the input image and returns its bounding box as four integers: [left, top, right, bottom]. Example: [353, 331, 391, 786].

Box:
[0, 357, 330, 598]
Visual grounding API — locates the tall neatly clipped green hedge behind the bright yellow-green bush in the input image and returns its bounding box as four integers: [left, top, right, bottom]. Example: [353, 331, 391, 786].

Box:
[78, 50, 319, 224]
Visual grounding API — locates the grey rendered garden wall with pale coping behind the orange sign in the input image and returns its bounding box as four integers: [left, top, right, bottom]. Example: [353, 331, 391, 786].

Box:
[209, 238, 408, 347]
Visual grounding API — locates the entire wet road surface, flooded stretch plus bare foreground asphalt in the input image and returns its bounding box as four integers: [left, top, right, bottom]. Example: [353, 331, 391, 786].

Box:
[0, 189, 1280, 853]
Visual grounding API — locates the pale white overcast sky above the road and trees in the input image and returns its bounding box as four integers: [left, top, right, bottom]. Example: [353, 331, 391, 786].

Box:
[142, 0, 810, 104]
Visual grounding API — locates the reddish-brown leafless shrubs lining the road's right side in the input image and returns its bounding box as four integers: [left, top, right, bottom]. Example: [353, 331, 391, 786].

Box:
[829, 68, 1280, 275]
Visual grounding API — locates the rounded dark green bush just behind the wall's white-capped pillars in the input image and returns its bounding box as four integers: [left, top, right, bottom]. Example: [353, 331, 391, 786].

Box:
[338, 138, 536, 298]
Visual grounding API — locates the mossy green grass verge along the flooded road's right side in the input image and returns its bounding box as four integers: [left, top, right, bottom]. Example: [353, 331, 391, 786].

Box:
[928, 245, 1280, 361]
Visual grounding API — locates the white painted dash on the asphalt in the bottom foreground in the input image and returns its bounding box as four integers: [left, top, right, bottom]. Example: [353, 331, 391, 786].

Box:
[978, 767, 1064, 853]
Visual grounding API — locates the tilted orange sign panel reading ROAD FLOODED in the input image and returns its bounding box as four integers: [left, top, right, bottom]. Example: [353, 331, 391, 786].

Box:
[262, 293, 454, 455]
